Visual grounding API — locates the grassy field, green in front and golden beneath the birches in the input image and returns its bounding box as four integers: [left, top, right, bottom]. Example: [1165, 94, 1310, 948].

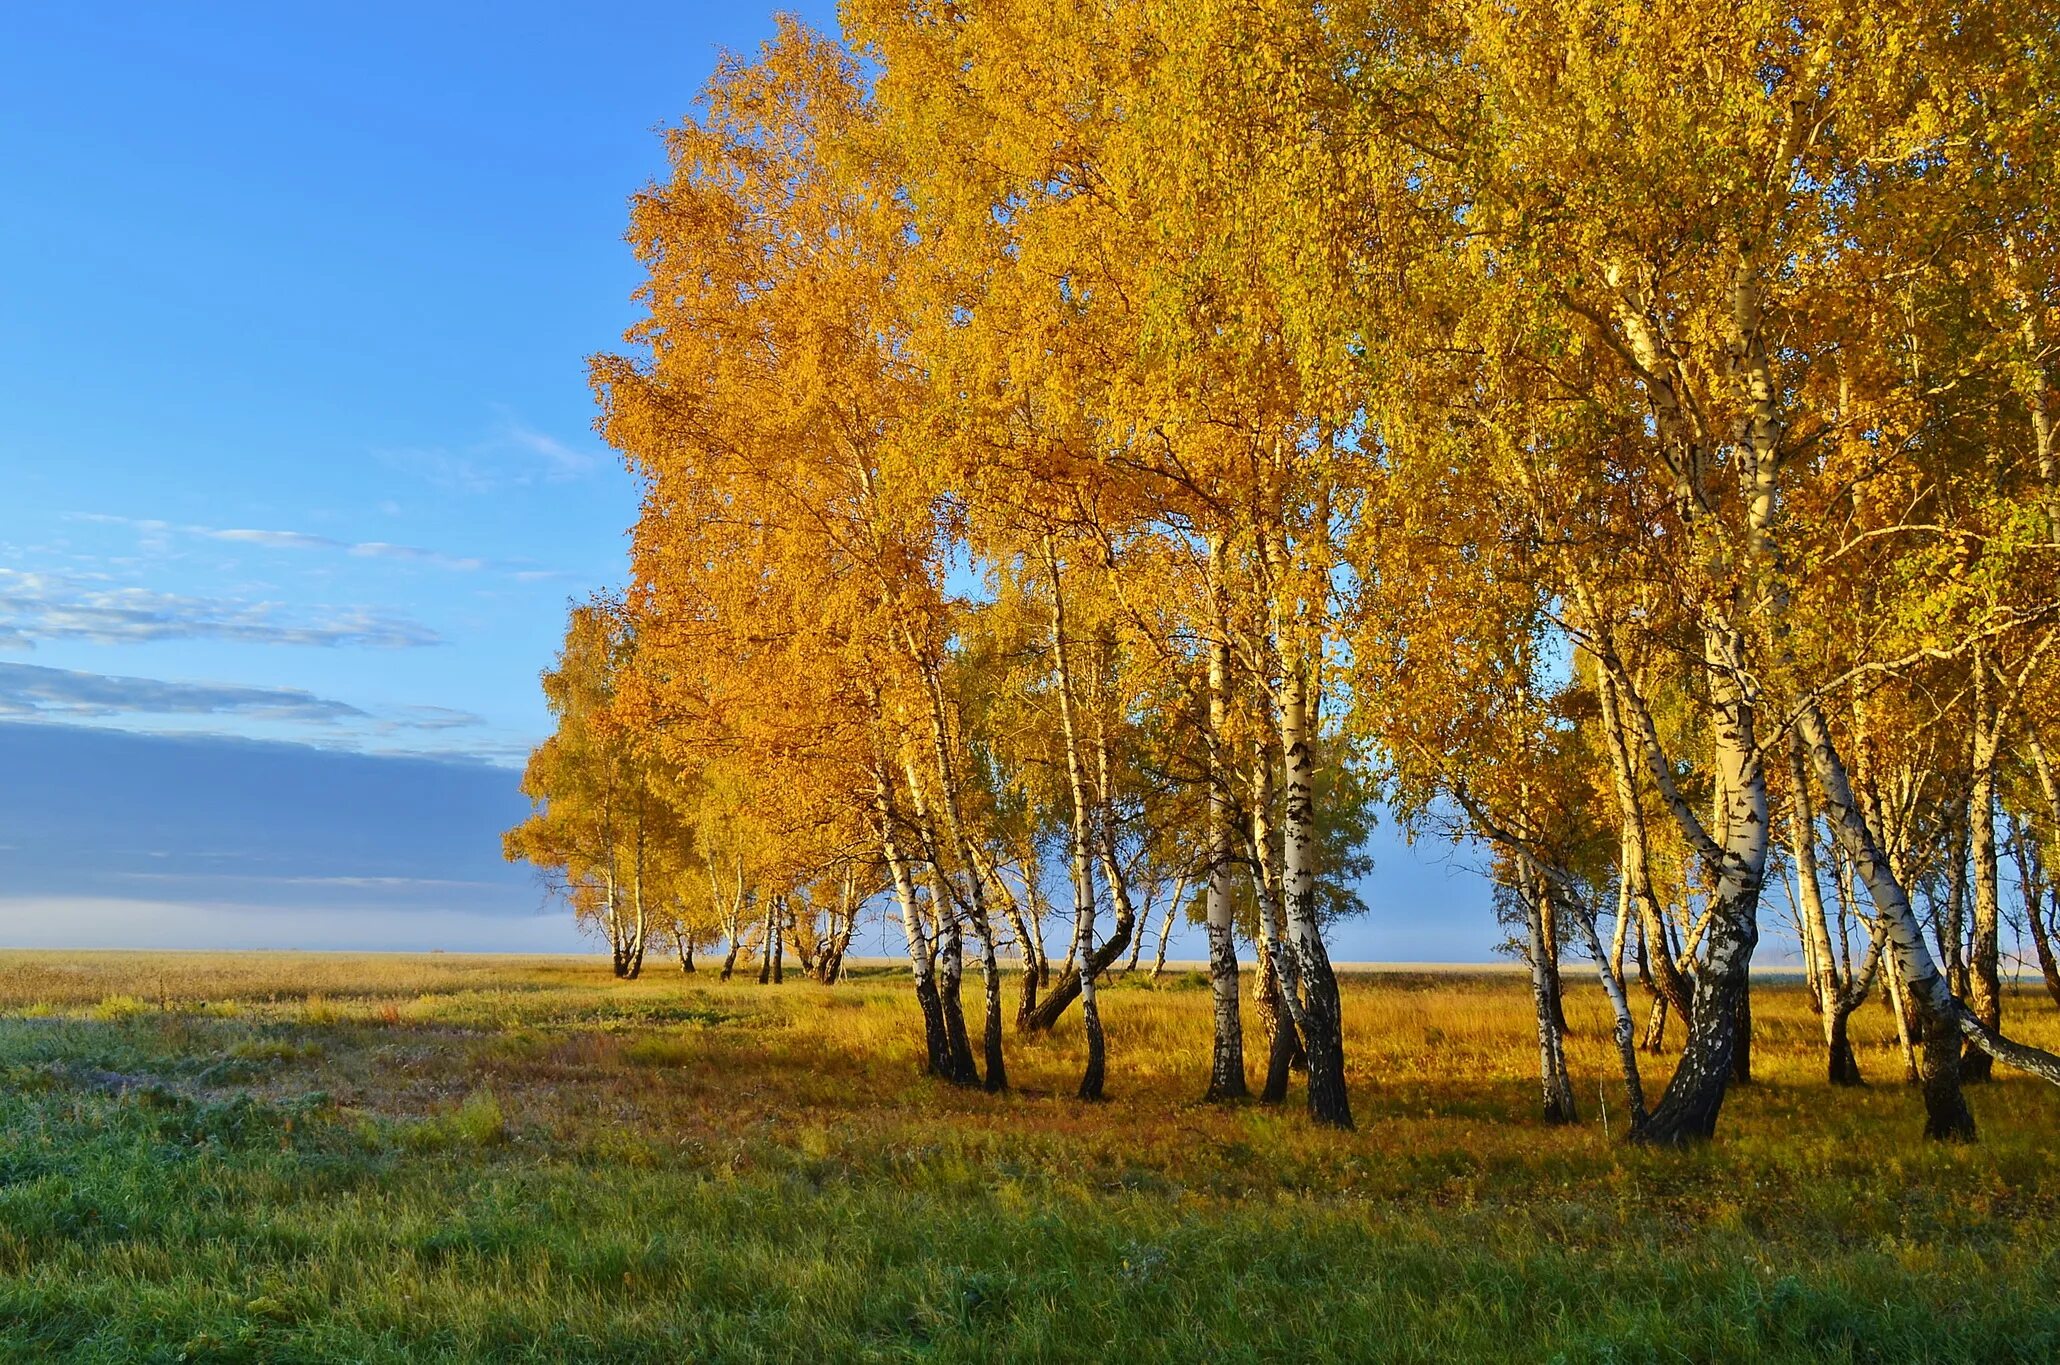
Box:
[0, 953, 2060, 1361]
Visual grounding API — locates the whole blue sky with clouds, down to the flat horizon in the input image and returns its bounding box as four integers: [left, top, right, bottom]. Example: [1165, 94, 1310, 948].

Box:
[0, 0, 1532, 959]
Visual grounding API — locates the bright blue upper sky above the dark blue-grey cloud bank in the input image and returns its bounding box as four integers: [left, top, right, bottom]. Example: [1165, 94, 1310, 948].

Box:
[0, 0, 824, 762]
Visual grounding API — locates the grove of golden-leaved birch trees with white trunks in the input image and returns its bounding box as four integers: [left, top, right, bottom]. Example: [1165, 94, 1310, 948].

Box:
[509, 0, 2060, 1143]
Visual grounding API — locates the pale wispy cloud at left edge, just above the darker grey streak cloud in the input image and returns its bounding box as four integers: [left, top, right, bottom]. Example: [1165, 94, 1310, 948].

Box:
[0, 568, 443, 649]
